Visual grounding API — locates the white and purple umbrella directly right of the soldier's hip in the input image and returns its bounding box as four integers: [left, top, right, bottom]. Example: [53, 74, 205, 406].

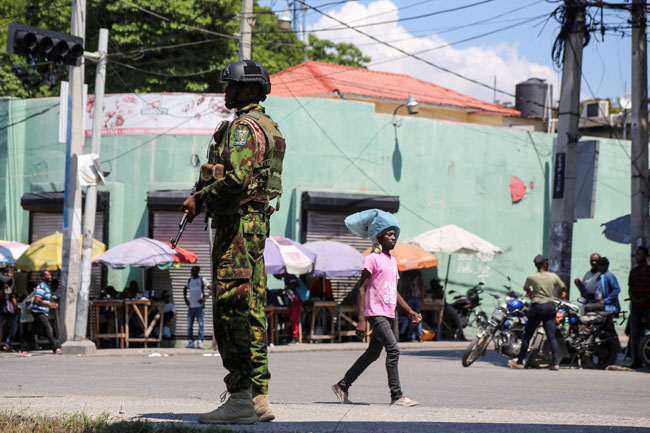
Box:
[264, 236, 316, 275]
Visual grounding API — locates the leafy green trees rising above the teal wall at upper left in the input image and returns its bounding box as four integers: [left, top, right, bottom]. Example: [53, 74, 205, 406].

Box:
[0, 0, 370, 98]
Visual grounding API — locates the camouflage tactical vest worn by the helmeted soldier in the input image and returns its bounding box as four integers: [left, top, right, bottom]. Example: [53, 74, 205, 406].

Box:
[200, 110, 286, 213]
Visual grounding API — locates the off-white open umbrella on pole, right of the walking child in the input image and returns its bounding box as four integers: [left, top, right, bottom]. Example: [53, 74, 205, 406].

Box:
[408, 224, 503, 335]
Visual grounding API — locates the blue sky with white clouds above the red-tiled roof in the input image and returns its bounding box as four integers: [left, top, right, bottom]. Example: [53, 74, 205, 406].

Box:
[260, 0, 631, 106]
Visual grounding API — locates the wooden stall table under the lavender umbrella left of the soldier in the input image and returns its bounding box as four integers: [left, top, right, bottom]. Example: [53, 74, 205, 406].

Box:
[124, 299, 165, 349]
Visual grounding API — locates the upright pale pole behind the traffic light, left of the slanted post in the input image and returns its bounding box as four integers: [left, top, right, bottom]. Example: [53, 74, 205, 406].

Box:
[59, 0, 86, 346]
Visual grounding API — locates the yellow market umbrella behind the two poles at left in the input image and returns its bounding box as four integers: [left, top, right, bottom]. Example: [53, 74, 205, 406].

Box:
[16, 232, 106, 271]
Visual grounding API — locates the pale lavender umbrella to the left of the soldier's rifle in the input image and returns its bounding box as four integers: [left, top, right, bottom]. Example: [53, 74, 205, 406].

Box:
[93, 237, 176, 269]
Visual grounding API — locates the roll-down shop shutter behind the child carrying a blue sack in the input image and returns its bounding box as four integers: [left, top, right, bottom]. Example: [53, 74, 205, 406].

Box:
[303, 210, 372, 302]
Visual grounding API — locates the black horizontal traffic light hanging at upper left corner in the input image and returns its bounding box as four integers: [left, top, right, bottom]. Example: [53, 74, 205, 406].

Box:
[7, 23, 84, 66]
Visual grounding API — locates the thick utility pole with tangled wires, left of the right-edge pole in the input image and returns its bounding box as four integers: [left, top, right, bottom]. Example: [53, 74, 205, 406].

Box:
[549, 0, 585, 295]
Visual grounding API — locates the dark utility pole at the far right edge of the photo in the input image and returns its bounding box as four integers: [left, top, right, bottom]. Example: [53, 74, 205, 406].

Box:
[630, 0, 650, 255]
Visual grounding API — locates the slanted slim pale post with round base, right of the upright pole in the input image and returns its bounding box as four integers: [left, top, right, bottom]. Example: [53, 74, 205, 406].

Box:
[69, 29, 108, 355]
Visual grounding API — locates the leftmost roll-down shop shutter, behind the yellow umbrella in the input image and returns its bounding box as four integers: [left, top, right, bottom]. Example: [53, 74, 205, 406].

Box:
[29, 211, 105, 299]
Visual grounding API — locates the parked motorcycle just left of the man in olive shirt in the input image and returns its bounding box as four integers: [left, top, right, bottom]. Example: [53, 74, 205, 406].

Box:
[462, 291, 528, 367]
